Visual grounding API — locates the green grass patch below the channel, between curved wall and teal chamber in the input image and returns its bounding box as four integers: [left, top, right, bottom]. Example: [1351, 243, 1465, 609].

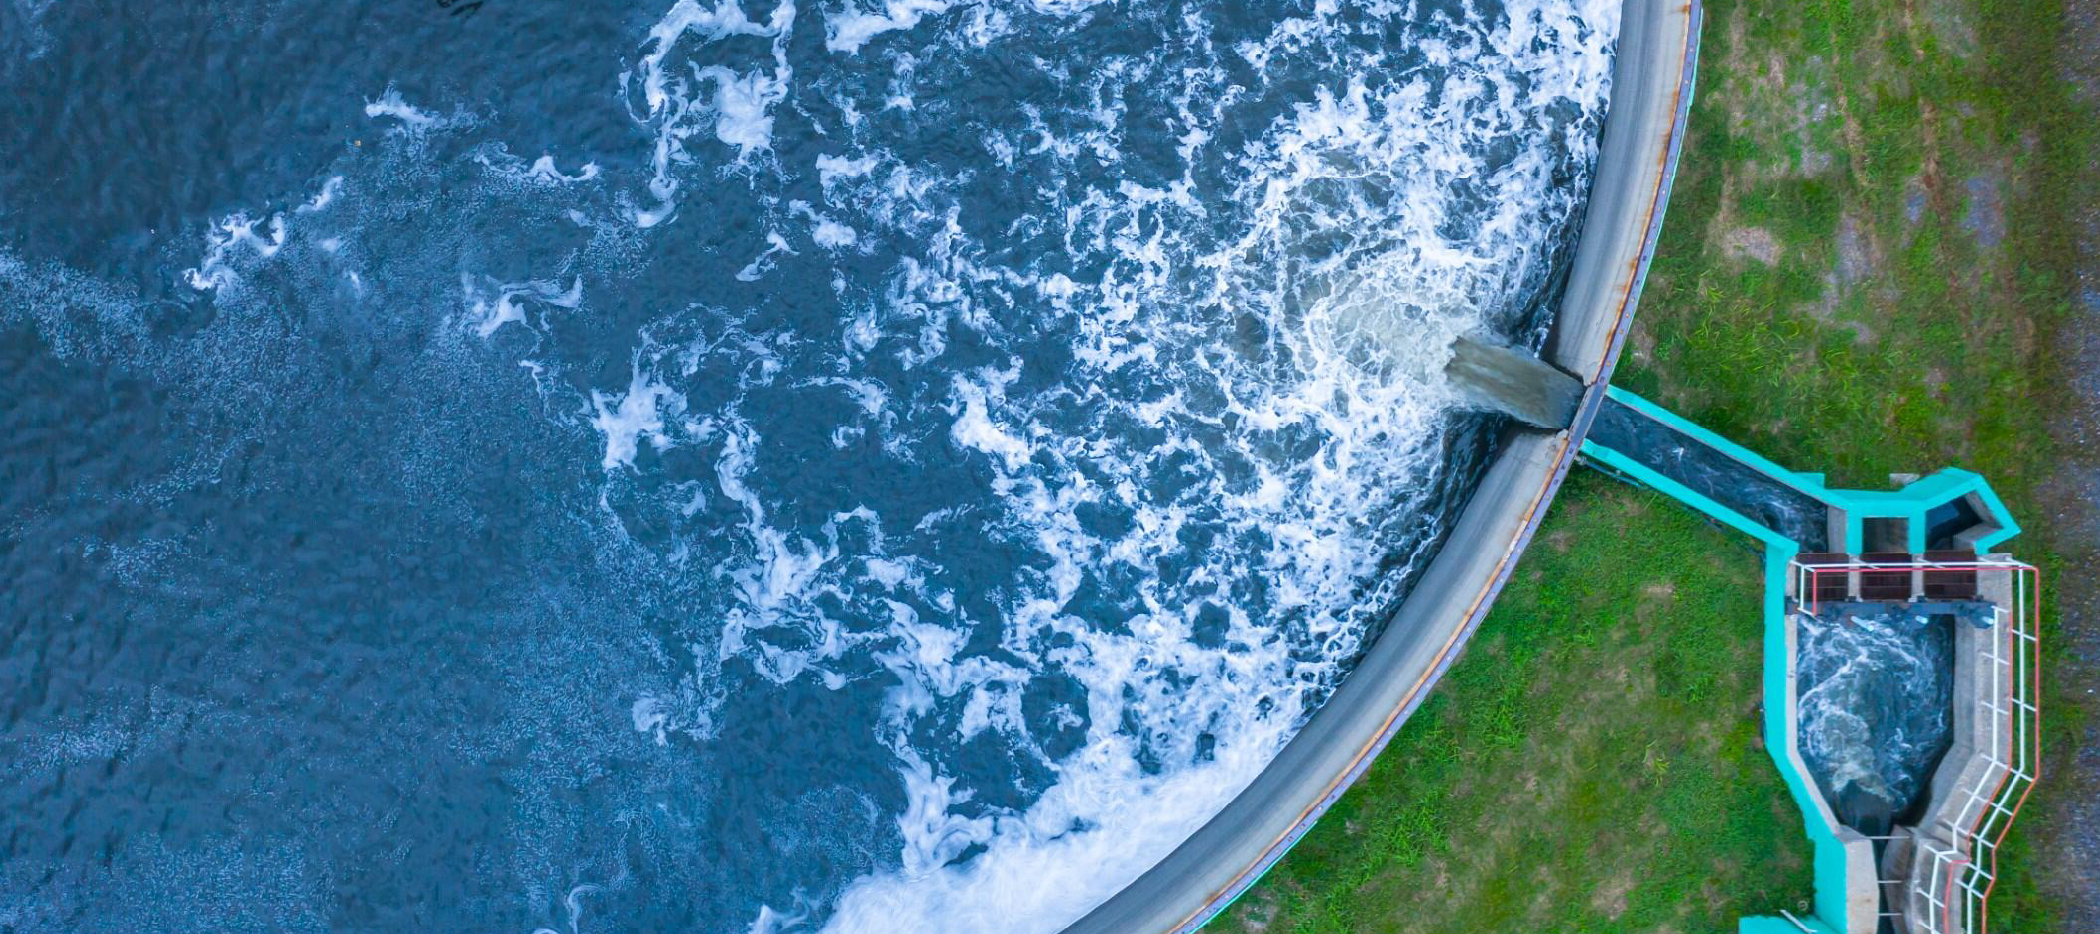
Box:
[1216, 472, 1808, 932]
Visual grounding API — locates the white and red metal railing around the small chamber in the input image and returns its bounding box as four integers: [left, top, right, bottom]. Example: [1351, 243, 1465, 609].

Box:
[1793, 556, 2041, 934]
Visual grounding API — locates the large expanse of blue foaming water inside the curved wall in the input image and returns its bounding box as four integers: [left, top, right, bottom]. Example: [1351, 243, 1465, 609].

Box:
[0, 0, 1617, 934]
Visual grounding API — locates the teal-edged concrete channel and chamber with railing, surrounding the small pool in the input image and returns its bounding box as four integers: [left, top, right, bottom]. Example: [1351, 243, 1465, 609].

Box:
[1581, 386, 2041, 934]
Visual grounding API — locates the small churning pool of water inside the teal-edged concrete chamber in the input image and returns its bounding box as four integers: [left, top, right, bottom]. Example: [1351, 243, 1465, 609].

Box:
[1800, 611, 1966, 833]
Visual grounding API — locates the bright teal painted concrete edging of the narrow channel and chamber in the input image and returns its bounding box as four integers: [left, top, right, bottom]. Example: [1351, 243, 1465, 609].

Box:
[1581, 386, 2020, 934]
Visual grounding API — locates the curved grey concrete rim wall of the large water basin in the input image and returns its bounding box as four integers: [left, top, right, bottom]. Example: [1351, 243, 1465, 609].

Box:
[1065, 0, 1699, 934]
